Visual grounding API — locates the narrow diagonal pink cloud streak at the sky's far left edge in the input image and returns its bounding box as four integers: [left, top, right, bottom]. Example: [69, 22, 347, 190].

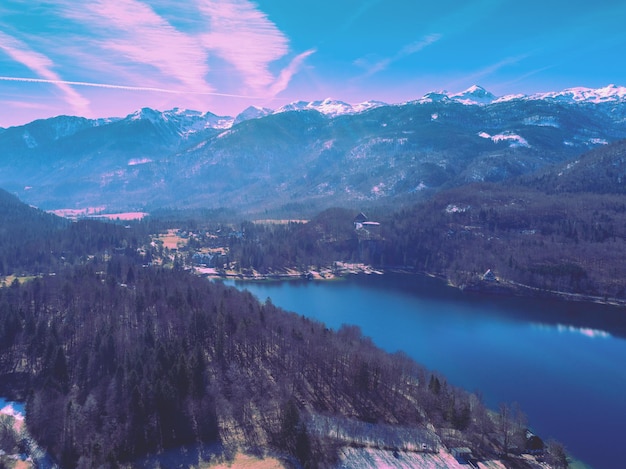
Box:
[0, 31, 89, 115]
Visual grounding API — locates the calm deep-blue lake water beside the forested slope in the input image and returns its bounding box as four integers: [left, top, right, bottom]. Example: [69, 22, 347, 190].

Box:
[225, 274, 626, 469]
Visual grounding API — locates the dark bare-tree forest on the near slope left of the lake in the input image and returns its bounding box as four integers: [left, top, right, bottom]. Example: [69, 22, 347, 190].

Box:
[0, 189, 565, 468]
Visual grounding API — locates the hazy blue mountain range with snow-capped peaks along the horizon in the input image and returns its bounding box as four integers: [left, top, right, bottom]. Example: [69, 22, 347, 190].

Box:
[0, 85, 626, 212]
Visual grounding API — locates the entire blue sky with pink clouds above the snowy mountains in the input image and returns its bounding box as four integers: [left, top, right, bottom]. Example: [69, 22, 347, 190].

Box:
[0, 0, 626, 127]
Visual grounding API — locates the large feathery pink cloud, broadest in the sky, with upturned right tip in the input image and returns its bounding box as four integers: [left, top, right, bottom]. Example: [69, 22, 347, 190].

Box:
[29, 0, 312, 98]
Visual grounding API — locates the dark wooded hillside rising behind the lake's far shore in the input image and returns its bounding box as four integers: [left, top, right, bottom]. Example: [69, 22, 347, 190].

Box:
[213, 179, 626, 299]
